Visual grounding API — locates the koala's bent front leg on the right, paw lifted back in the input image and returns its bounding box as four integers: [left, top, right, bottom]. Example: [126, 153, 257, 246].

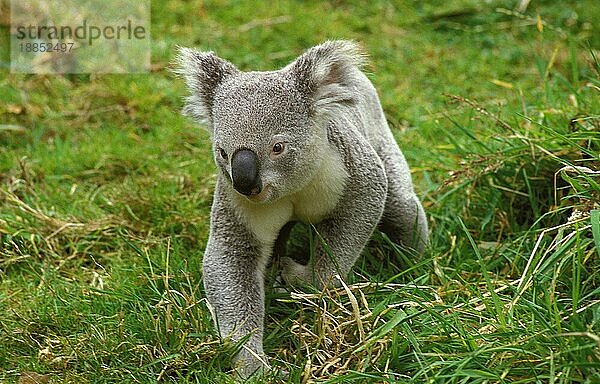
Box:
[282, 134, 387, 288]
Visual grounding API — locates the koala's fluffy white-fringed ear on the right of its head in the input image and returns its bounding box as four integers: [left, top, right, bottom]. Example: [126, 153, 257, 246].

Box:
[284, 40, 366, 112]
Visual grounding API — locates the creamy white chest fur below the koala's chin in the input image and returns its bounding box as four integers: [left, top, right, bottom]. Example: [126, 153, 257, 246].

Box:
[236, 151, 348, 244]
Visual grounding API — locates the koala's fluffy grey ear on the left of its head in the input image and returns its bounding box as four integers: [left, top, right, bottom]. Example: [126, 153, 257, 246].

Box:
[174, 47, 239, 129]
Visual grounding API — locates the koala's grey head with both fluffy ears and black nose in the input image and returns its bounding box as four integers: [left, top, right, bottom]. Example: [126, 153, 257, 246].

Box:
[177, 41, 363, 203]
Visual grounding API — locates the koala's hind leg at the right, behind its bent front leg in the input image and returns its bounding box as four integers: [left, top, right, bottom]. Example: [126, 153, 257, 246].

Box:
[379, 174, 429, 254]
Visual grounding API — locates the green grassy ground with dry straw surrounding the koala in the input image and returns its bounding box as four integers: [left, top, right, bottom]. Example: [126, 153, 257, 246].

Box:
[0, 0, 600, 383]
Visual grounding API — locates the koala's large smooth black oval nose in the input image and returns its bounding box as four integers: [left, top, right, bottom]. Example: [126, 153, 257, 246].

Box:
[231, 149, 262, 196]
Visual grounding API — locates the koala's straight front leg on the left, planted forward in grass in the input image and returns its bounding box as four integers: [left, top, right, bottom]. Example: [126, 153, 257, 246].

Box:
[203, 186, 269, 378]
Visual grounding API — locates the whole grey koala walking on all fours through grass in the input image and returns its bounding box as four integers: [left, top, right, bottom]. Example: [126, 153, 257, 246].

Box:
[175, 41, 428, 378]
